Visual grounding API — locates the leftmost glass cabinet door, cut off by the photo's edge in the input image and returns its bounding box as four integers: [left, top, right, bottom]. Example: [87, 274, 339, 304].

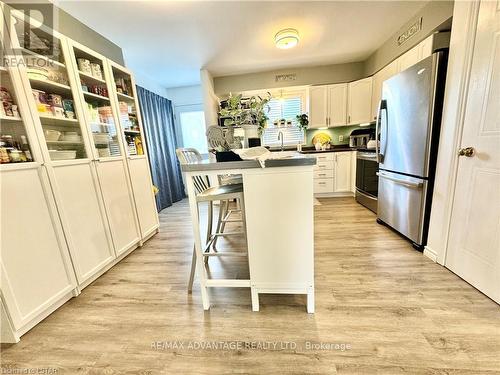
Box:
[0, 40, 33, 164]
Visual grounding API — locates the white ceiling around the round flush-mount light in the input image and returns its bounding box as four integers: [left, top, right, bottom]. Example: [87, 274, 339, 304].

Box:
[56, 0, 426, 87]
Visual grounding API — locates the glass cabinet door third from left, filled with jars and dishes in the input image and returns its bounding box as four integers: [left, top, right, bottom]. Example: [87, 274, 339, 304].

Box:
[71, 43, 121, 158]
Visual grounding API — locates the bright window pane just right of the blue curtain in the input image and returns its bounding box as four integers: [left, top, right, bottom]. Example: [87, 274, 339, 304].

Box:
[179, 111, 208, 154]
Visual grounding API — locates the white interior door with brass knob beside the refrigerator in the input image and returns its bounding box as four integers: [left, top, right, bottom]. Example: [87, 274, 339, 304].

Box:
[445, 1, 500, 303]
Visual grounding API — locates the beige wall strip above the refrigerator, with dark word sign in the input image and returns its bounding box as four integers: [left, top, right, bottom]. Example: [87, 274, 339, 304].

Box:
[364, 1, 453, 77]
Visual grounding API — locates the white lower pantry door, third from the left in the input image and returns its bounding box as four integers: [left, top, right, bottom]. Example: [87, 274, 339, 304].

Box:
[96, 158, 141, 256]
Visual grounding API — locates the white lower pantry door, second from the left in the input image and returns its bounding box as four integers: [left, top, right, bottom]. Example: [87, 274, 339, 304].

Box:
[49, 161, 116, 286]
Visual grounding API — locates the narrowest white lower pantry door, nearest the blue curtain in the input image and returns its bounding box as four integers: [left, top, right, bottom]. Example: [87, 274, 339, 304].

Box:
[128, 157, 159, 239]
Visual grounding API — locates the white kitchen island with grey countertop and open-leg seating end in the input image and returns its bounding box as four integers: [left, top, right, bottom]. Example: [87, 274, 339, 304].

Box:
[181, 154, 316, 313]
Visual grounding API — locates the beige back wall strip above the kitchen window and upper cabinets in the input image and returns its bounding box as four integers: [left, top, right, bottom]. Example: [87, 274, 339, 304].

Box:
[214, 62, 364, 96]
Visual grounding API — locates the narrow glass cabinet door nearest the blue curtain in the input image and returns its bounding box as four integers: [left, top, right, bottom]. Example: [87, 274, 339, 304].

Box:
[111, 65, 144, 155]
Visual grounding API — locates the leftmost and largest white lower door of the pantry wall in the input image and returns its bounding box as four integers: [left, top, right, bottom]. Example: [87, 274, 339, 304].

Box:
[0, 163, 76, 341]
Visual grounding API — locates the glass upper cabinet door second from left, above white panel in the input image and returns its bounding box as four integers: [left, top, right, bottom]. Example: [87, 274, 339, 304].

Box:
[12, 12, 88, 161]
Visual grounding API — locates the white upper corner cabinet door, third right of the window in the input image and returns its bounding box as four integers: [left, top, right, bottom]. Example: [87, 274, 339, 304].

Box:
[347, 77, 372, 125]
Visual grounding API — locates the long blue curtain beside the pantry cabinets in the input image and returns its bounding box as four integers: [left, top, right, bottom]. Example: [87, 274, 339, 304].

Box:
[137, 86, 184, 211]
